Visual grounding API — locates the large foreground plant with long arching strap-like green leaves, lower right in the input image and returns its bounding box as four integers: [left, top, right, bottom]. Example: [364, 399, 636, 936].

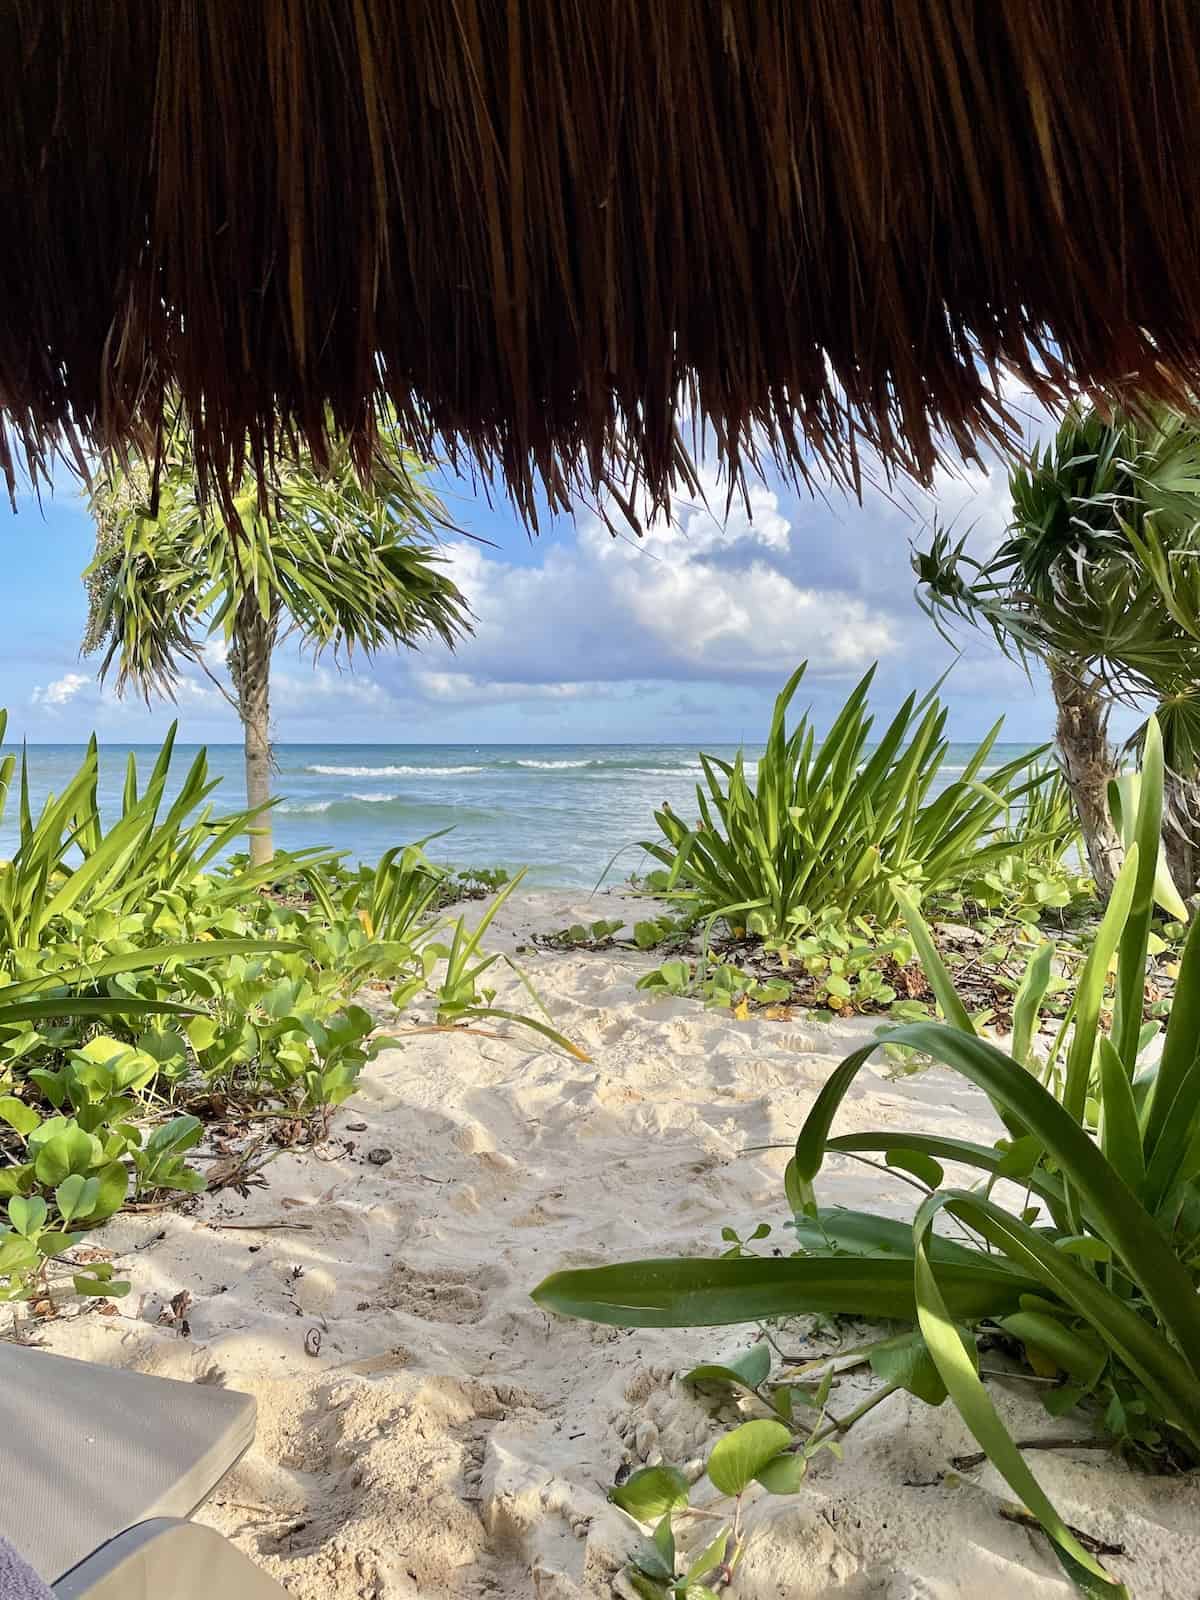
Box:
[534, 720, 1200, 1595]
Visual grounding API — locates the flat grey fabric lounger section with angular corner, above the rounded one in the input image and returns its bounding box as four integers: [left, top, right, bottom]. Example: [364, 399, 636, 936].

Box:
[0, 1342, 254, 1582]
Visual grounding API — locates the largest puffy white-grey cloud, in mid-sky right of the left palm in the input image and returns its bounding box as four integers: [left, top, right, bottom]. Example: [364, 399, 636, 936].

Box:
[414, 483, 898, 704]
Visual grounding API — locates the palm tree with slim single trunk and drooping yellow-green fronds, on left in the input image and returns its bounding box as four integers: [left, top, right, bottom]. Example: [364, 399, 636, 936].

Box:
[83, 432, 470, 864]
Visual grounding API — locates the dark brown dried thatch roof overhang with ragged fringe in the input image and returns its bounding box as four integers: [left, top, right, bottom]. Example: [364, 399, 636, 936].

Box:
[0, 0, 1200, 518]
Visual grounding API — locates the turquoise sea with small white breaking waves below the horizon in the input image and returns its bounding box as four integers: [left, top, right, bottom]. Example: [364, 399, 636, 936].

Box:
[0, 744, 1043, 888]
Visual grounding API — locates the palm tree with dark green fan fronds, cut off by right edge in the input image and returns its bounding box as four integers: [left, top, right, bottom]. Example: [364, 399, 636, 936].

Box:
[914, 406, 1200, 896]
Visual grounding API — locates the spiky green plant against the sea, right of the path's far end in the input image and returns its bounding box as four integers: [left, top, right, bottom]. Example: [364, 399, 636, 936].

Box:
[643, 664, 1048, 939]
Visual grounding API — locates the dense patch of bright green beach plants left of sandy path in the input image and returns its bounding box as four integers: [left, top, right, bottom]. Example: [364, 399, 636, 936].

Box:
[0, 726, 581, 1299]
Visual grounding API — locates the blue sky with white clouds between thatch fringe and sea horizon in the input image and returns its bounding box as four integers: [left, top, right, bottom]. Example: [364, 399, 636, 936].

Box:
[0, 396, 1113, 744]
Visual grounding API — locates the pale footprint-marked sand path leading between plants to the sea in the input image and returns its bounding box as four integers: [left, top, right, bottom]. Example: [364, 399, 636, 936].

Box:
[21, 893, 1200, 1600]
